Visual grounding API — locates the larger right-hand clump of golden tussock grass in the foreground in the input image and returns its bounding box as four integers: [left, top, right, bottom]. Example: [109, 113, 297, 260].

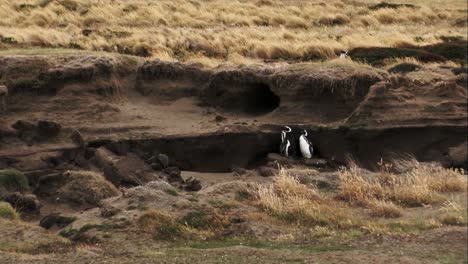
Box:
[337, 159, 467, 209]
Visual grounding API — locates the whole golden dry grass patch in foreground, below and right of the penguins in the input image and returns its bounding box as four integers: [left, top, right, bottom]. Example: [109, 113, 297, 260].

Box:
[255, 157, 467, 228]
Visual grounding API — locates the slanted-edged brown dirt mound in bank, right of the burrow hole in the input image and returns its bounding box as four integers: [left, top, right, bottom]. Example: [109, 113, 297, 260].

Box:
[347, 77, 467, 126]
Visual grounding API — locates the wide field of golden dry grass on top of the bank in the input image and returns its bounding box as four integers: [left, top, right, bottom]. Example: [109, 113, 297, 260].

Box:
[0, 0, 467, 65]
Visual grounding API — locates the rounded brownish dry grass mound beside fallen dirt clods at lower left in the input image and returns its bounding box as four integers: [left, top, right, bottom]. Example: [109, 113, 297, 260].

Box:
[58, 171, 119, 205]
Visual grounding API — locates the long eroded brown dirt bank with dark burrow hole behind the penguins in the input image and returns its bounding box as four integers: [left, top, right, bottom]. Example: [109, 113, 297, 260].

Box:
[0, 56, 467, 171]
